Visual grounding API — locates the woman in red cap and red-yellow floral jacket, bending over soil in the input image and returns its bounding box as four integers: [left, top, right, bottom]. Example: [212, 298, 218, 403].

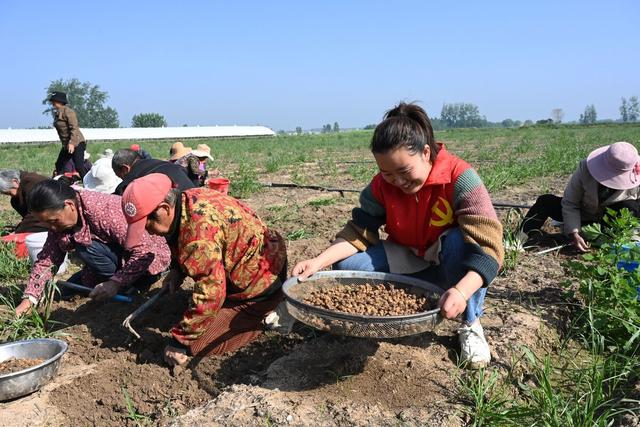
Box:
[122, 173, 286, 365]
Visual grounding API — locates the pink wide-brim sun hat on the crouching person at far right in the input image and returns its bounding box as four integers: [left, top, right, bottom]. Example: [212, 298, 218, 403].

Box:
[587, 142, 640, 190]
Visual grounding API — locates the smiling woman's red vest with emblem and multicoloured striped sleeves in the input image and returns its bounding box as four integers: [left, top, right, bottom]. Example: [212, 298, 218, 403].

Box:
[338, 145, 504, 286]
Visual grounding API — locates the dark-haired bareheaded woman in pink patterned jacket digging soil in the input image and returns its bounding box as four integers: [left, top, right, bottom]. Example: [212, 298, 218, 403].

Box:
[16, 179, 171, 315]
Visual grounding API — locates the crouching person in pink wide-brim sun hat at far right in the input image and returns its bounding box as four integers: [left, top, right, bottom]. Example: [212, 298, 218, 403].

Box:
[522, 142, 640, 252]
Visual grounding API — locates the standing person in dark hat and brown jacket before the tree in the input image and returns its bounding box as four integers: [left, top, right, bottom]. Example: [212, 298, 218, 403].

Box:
[49, 92, 87, 178]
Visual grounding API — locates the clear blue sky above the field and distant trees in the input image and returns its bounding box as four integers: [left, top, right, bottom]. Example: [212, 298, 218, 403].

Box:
[0, 0, 640, 130]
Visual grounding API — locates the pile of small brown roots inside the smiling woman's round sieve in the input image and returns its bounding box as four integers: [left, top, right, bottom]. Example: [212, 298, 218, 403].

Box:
[304, 284, 435, 316]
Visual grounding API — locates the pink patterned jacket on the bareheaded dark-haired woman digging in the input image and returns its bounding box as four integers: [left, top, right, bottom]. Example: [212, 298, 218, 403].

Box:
[24, 190, 171, 302]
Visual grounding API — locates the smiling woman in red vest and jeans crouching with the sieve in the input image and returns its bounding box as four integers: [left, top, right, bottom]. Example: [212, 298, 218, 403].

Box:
[293, 103, 504, 366]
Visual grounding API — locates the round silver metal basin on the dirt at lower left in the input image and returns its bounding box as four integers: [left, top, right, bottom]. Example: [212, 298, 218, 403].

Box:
[0, 338, 67, 401]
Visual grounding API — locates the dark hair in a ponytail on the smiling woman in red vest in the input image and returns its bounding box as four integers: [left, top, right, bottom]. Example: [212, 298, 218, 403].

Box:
[371, 102, 439, 162]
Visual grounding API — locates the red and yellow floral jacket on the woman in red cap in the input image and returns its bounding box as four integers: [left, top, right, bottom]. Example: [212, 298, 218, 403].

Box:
[171, 188, 287, 345]
